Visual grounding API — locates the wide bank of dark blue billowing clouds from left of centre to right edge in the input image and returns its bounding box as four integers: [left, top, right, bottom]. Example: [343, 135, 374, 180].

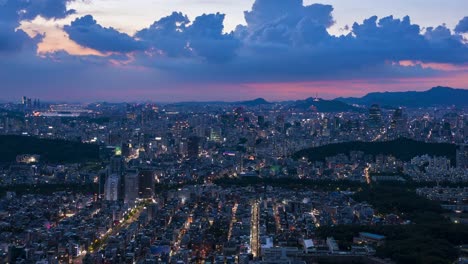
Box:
[54, 0, 468, 86]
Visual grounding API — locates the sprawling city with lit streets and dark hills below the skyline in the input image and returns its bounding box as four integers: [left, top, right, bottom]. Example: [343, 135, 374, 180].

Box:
[0, 88, 468, 263]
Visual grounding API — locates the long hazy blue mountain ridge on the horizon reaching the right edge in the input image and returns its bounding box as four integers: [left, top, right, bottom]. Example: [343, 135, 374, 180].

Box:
[335, 86, 468, 107]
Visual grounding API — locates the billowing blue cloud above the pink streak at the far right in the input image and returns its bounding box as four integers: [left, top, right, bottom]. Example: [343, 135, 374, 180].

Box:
[350, 16, 468, 64]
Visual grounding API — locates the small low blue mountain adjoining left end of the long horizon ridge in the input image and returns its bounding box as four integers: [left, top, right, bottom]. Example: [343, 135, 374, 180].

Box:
[290, 98, 359, 113]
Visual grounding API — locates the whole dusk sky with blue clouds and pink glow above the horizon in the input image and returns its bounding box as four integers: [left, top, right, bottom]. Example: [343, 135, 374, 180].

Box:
[0, 0, 468, 102]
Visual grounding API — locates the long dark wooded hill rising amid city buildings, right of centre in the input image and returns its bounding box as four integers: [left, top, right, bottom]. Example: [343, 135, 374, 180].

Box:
[293, 138, 457, 164]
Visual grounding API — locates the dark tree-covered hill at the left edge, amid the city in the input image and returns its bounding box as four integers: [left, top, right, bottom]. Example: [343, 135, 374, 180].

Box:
[0, 135, 99, 163]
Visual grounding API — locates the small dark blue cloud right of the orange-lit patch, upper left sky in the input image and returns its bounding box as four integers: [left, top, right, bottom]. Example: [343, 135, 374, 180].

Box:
[64, 15, 144, 53]
